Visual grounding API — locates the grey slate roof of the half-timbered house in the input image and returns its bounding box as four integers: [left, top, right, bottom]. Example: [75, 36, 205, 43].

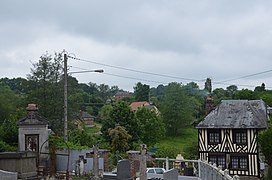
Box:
[196, 100, 267, 129]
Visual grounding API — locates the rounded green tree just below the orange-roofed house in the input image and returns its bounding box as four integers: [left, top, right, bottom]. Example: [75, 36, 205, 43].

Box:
[136, 107, 165, 146]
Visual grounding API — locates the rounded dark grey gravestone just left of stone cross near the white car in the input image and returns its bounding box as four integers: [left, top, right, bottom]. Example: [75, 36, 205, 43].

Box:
[117, 160, 132, 180]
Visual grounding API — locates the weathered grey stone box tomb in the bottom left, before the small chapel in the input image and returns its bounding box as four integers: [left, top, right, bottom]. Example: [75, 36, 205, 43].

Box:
[0, 152, 37, 179]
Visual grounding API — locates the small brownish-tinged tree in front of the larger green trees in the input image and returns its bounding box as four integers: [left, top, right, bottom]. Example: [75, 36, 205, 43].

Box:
[109, 126, 131, 153]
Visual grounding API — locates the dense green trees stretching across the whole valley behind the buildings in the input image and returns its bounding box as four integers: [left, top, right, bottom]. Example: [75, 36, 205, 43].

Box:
[0, 53, 272, 167]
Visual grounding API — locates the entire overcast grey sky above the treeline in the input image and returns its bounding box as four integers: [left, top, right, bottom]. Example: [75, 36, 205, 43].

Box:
[0, 0, 272, 91]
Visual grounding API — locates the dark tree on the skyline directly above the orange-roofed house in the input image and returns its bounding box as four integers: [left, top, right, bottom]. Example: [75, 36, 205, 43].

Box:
[134, 82, 149, 101]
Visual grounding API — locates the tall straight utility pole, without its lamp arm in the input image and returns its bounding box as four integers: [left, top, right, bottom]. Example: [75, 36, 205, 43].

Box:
[63, 53, 68, 143]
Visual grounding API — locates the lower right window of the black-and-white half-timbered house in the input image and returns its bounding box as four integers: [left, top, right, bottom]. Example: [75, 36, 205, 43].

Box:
[230, 154, 249, 170]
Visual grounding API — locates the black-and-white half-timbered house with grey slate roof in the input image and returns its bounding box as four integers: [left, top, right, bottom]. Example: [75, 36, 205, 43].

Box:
[196, 100, 268, 178]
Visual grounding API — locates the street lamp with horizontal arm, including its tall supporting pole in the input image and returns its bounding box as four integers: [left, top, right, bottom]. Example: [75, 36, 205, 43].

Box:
[64, 54, 104, 142]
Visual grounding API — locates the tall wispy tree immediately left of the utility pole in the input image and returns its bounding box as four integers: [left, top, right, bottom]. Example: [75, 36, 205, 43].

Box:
[27, 53, 63, 132]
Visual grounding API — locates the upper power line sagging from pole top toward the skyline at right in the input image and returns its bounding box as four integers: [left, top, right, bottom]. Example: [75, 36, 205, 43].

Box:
[68, 56, 205, 82]
